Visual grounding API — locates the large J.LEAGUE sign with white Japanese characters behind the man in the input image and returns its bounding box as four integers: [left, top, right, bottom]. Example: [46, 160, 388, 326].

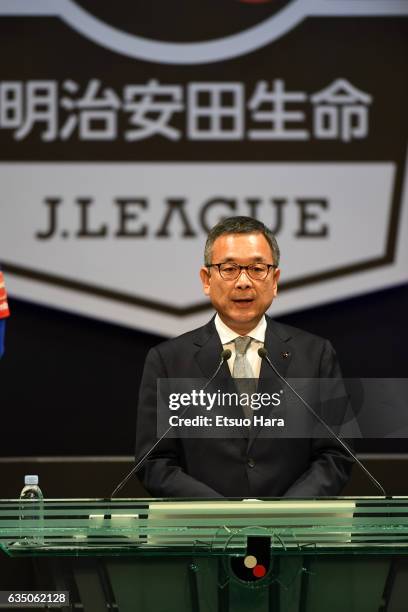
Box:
[0, 0, 408, 335]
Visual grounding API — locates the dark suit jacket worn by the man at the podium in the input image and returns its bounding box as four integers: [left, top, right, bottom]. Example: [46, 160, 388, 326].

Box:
[136, 317, 352, 498]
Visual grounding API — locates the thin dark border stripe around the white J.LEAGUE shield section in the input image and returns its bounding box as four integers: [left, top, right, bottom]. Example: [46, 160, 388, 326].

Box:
[2, 157, 406, 317]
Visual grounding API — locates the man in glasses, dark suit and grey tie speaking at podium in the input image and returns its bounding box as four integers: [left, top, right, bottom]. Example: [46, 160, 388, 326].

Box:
[136, 217, 352, 498]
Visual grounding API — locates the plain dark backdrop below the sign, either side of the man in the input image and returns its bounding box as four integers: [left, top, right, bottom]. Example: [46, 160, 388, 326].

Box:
[0, 285, 408, 456]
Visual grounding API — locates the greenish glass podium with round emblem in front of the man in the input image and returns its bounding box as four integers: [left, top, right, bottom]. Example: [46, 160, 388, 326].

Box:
[0, 497, 408, 612]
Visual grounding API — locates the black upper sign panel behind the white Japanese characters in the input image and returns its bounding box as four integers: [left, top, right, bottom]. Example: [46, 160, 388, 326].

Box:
[0, 16, 408, 163]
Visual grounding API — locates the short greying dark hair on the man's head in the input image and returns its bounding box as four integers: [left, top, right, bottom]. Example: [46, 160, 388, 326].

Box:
[204, 217, 280, 266]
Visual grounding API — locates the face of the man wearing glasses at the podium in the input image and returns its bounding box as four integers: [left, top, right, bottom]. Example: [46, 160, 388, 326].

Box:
[200, 233, 280, 335]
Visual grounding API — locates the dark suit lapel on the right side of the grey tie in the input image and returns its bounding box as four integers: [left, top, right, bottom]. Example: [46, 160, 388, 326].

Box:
[248, 317, 292, 450]
